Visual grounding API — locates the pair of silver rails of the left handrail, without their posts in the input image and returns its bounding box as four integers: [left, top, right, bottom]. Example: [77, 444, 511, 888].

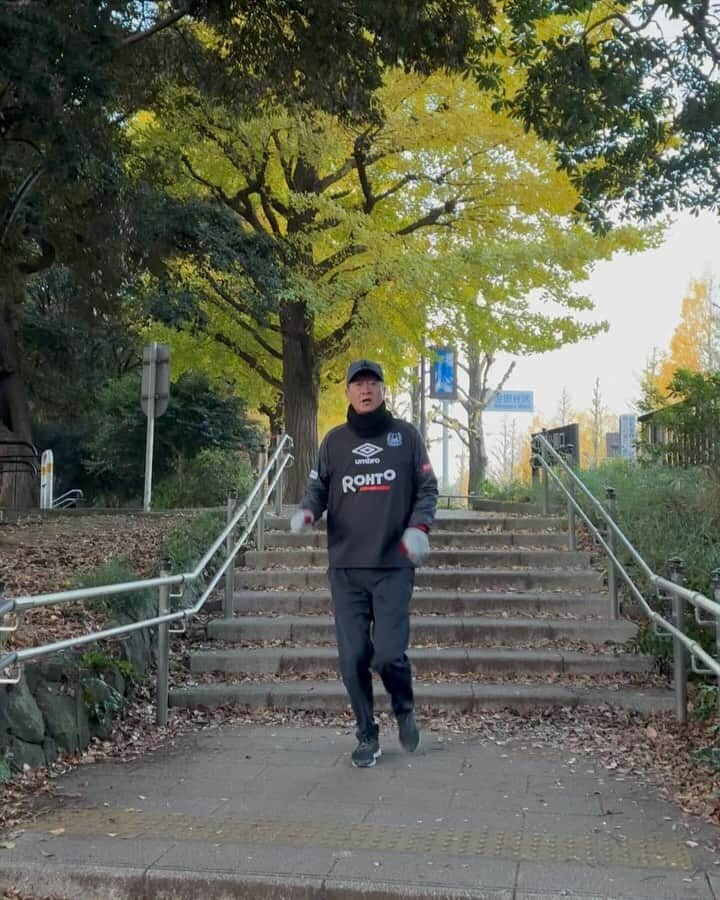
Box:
[0, 434, 293, 683]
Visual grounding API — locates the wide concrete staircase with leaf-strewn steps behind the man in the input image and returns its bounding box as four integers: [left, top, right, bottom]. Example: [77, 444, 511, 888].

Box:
[170, 501, 671, 712]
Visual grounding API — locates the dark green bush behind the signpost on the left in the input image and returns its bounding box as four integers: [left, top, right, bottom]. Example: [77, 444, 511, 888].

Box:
[87, 372, 261, 498]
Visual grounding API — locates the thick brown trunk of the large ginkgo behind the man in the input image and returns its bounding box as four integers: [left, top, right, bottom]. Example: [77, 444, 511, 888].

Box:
[280, 303, 320, 503]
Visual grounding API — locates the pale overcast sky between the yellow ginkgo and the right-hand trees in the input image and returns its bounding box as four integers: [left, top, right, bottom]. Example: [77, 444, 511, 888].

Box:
[431, 213, 720, 486]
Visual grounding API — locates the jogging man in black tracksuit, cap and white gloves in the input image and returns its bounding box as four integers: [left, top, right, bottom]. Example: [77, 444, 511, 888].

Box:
[290, 359, 437, 767]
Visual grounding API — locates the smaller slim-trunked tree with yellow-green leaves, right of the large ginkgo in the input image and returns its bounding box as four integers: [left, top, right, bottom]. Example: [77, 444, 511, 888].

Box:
[428, 214, 654, 494]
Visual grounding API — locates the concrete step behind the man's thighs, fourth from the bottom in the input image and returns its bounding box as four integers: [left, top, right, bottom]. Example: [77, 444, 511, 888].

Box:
[218, 590, 610, 616]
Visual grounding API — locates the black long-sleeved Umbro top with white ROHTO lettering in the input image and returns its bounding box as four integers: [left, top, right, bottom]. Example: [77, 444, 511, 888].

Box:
[301, 418, 438, 569]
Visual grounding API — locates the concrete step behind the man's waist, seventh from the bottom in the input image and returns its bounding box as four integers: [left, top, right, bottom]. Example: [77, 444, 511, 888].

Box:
[265, 531, 568, 550]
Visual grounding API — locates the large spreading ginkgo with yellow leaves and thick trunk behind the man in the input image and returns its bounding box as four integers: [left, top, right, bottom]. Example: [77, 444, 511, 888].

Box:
[132, 63, 641, 500]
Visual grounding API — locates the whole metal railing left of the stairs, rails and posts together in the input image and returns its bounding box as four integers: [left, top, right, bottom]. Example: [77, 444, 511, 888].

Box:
[0, 434, 293, 725]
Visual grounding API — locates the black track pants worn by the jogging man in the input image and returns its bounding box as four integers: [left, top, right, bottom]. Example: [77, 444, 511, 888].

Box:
[328, 566, 415, 738]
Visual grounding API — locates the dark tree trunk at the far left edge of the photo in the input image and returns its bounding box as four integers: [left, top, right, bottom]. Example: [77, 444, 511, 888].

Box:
[0, 293, 39, 509]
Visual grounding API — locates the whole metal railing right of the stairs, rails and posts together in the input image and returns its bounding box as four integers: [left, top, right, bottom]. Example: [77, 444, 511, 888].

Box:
[533, 434, 720, 722]
